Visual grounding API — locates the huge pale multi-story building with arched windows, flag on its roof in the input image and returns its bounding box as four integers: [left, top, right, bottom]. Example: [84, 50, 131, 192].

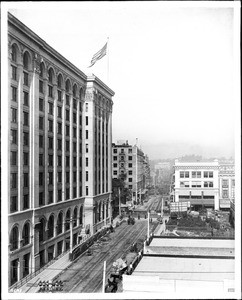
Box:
[8, 14, 114, 285]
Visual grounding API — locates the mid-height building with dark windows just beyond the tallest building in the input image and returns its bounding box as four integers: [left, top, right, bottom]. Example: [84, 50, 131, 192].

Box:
[112, 140, 150, 202]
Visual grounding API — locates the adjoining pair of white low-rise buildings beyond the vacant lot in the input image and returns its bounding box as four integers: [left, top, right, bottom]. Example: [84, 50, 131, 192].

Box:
[171, 159, 235, 210]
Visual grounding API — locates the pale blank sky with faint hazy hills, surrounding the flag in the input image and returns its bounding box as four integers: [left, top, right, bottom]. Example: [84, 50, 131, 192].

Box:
[3, 2, 240, 159]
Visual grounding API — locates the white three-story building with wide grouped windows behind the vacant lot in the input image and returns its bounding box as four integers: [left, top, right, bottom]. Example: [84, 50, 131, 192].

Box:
[174, 160, 219, 210]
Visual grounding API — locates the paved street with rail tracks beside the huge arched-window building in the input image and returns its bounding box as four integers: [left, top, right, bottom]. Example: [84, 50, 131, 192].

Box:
[57, 219, 147, 293]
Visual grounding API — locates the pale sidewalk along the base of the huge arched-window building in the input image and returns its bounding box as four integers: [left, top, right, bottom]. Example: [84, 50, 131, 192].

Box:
[20, 217, 121, 293]
